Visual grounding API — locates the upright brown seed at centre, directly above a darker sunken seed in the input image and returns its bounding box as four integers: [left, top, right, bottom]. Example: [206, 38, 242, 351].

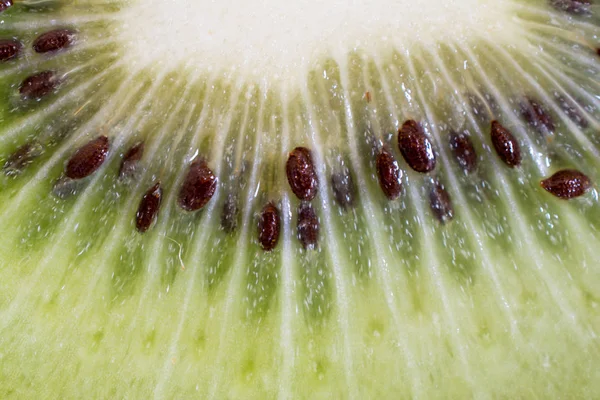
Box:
[285, 147, 319, 201]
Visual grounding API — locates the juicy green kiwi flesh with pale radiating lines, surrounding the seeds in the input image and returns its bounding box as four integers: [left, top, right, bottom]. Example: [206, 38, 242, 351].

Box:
[0, 2, 600, 399]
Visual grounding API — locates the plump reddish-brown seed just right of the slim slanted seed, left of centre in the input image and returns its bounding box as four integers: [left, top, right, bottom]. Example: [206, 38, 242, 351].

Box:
[179, 160, 217, 211]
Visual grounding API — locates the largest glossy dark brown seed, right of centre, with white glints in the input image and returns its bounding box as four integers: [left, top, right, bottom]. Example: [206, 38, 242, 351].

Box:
[398, 119, 435, 173]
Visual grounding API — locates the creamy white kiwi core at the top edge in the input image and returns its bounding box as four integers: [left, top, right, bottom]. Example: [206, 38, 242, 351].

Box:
[118, 0, 515, 79]
